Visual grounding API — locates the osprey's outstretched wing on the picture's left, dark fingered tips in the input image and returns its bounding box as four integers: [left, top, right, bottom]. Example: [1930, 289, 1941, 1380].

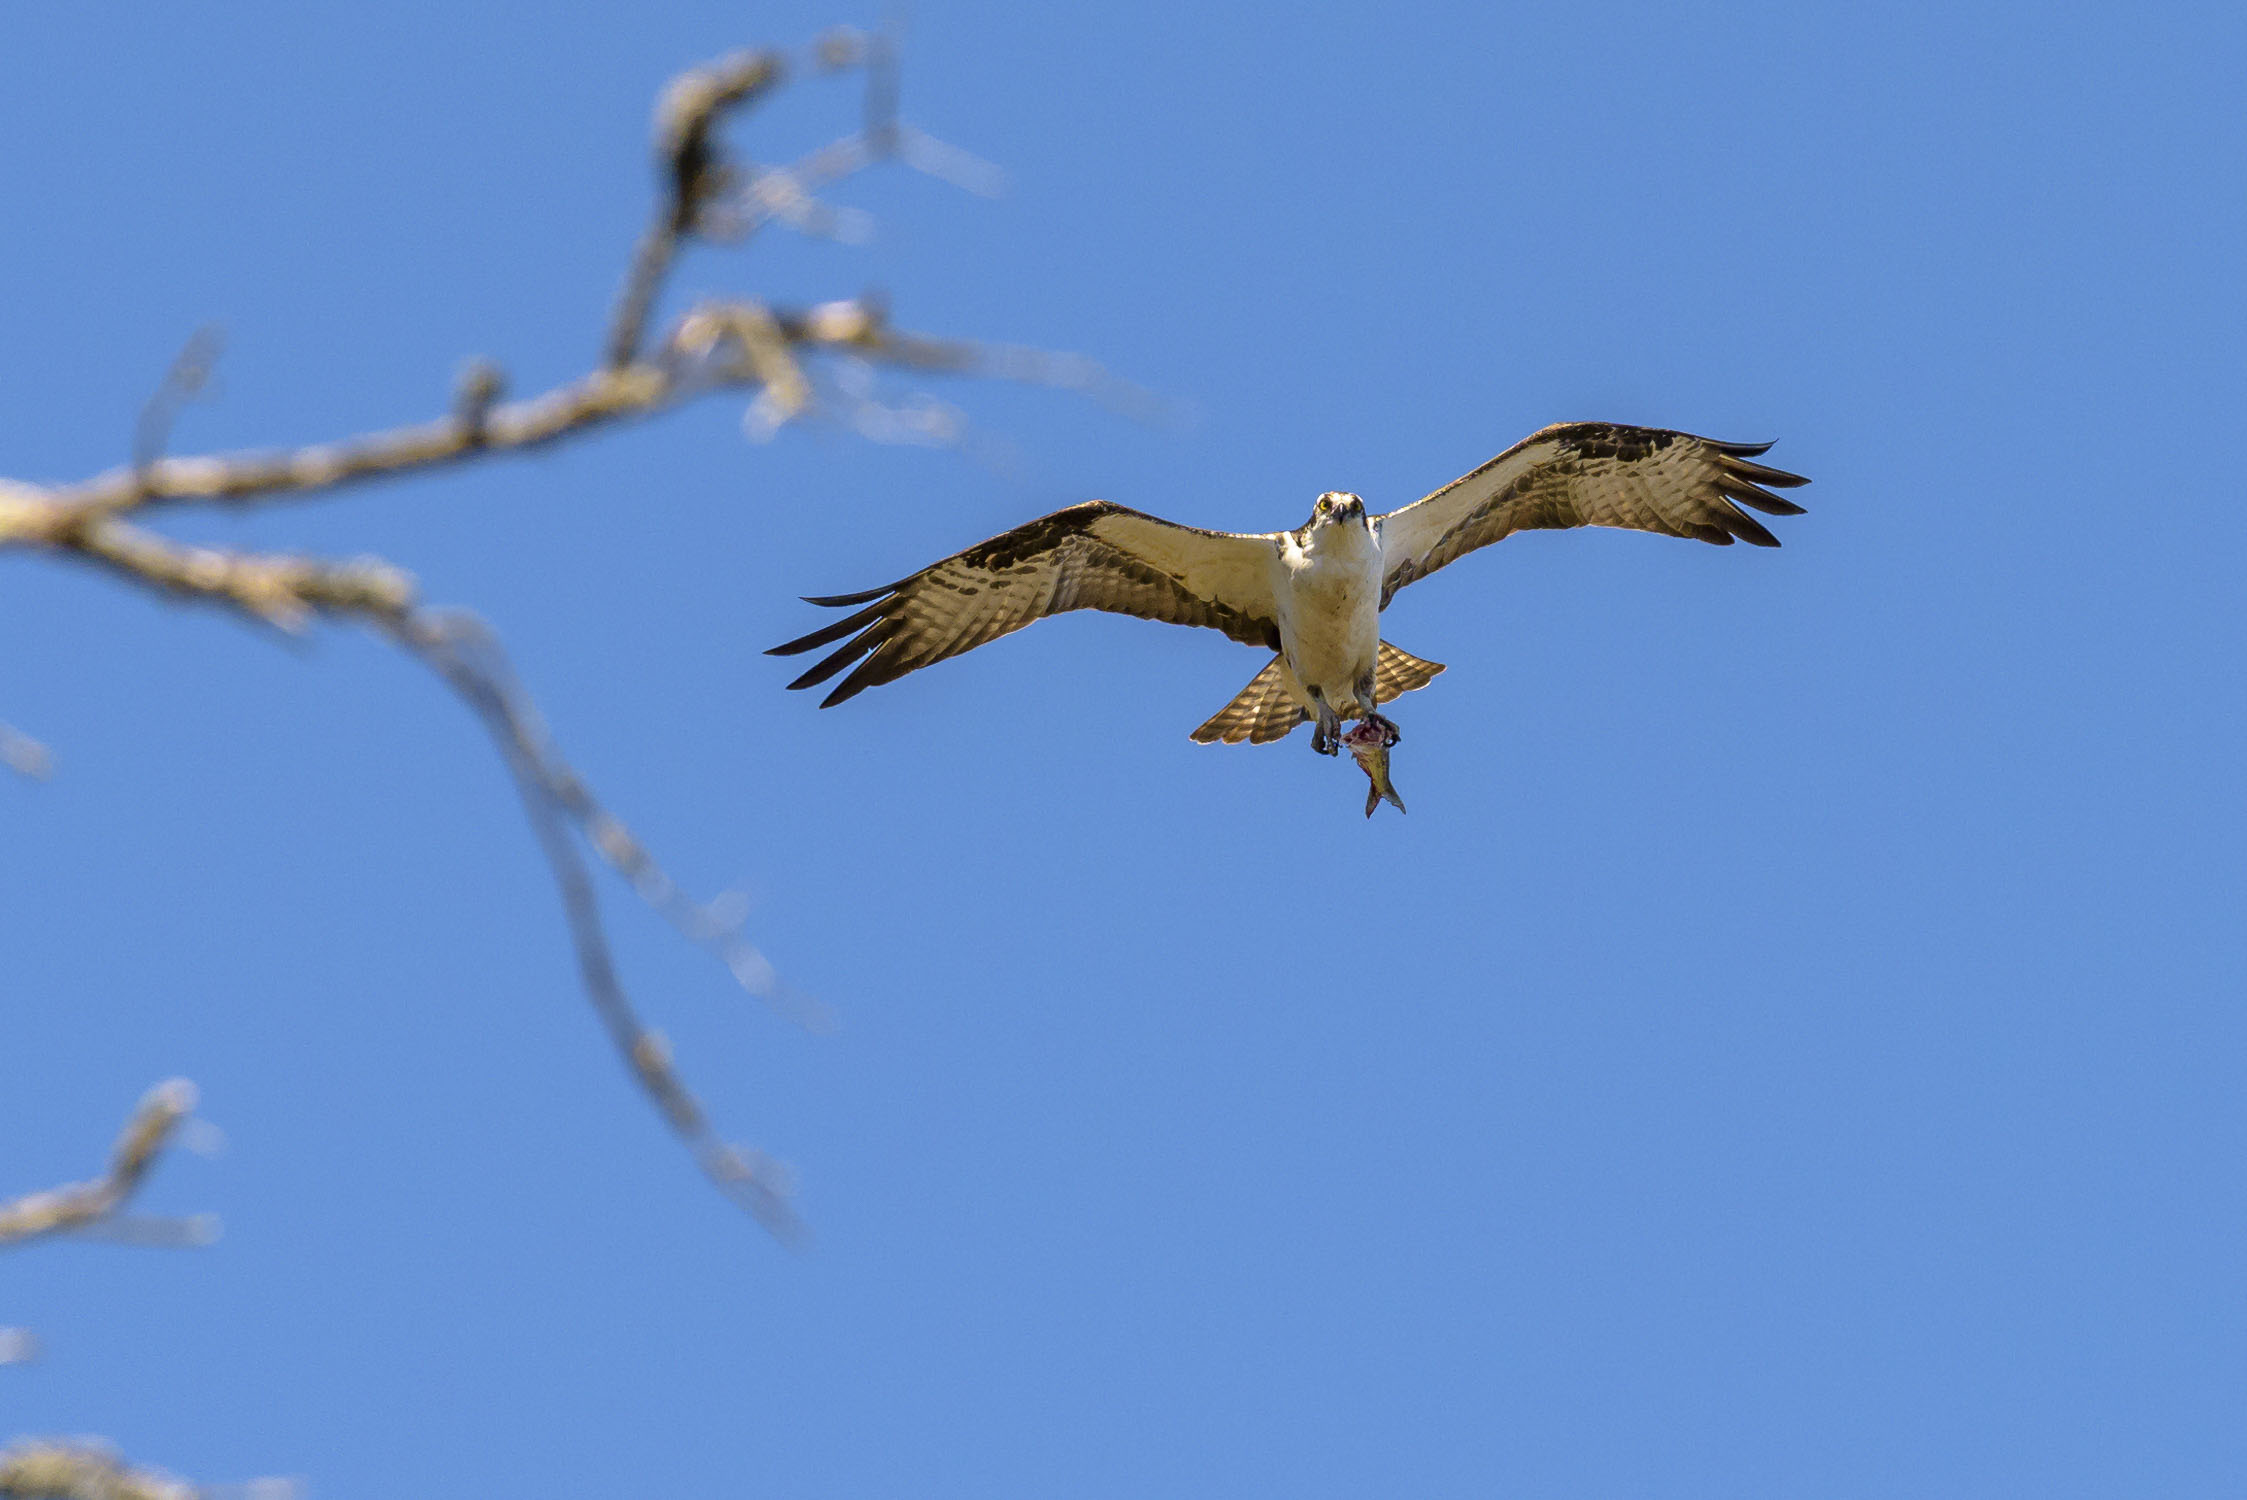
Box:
[766, 501, 1279, 707]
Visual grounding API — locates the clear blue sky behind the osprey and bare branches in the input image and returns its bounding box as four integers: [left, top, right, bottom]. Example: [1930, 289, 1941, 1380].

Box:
[0, 2, 2247, 1500]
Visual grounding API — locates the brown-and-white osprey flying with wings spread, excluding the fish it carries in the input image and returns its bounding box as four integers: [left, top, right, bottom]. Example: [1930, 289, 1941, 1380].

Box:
[768, 422, 1809, 754]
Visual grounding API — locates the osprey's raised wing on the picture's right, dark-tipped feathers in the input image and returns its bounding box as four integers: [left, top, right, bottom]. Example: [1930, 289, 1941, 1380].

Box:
[1380, 422, 1809, 606]
